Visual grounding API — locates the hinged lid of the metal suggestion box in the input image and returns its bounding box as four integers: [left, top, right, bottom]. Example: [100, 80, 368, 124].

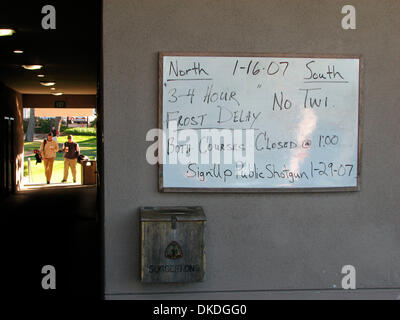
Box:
[139, 206, 207, 222]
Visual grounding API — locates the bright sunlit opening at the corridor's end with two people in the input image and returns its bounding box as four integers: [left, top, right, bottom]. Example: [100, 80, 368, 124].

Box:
[23, 108, 97, 189]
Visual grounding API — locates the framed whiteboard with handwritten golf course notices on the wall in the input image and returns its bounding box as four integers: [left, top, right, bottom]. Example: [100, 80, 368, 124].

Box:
[158, 53, 360, 192]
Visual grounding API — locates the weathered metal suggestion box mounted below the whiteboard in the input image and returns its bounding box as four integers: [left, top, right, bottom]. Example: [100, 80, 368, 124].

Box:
[139, 207, 206, 283]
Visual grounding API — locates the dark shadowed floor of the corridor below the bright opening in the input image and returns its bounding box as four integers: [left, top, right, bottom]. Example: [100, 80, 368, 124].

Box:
[1, 185, 101, 299]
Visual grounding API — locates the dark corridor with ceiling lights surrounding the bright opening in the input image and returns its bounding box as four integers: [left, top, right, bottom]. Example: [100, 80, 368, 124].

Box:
[0, 0, 103, 299]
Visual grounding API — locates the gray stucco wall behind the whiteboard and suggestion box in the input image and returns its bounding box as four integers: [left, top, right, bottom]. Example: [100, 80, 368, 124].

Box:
[103, 0, 400, 299]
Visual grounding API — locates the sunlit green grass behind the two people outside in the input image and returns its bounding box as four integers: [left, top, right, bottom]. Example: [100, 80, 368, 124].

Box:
[24, 135, 97, 183]
